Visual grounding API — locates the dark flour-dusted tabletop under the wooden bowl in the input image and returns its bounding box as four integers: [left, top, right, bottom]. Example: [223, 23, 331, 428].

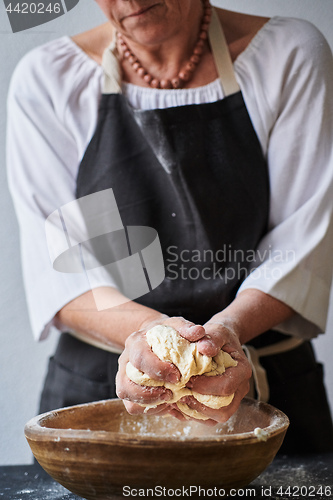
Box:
[0, 454, 333, 500]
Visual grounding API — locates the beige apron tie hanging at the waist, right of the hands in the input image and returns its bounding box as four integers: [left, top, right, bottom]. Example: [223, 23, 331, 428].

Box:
[243, 337, 304, 403]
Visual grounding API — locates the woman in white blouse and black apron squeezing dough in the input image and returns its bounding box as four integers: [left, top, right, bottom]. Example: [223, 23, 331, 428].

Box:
[9, 0, 333, 452]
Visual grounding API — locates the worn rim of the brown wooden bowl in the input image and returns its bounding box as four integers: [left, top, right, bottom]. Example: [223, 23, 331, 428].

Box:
[24, 398, 290, 446]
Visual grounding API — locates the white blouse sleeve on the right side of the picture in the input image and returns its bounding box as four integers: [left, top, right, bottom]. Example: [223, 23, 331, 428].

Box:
[237, 18, 333, 338]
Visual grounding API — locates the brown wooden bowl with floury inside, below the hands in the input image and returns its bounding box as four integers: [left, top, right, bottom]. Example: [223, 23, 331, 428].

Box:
[25, 399, 289, 499]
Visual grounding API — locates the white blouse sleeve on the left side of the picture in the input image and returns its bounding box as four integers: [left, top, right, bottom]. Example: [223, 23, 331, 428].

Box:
[7, 37, 114, 339]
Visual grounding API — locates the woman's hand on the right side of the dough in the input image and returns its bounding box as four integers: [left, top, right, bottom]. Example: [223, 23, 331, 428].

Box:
[182, 321, 252, 422]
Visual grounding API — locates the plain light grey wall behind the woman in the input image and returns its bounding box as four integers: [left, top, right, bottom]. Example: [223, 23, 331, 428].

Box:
[0, 0, 333, 465]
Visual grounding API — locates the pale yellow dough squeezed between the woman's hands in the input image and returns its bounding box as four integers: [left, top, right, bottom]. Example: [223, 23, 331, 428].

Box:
[126, 325, 237, 420]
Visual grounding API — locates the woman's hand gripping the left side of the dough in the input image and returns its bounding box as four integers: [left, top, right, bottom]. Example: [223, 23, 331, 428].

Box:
[116, 316, 205, 419]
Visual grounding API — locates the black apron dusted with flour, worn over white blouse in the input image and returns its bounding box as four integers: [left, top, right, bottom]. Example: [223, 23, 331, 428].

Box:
[41, 9, 333, 451]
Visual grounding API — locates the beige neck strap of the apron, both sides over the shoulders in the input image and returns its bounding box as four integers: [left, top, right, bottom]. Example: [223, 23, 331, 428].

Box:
[102, 8, 240, 97]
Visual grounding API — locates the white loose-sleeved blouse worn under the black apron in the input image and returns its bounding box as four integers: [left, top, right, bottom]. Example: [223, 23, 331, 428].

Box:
[7, 17, 333, 339]
